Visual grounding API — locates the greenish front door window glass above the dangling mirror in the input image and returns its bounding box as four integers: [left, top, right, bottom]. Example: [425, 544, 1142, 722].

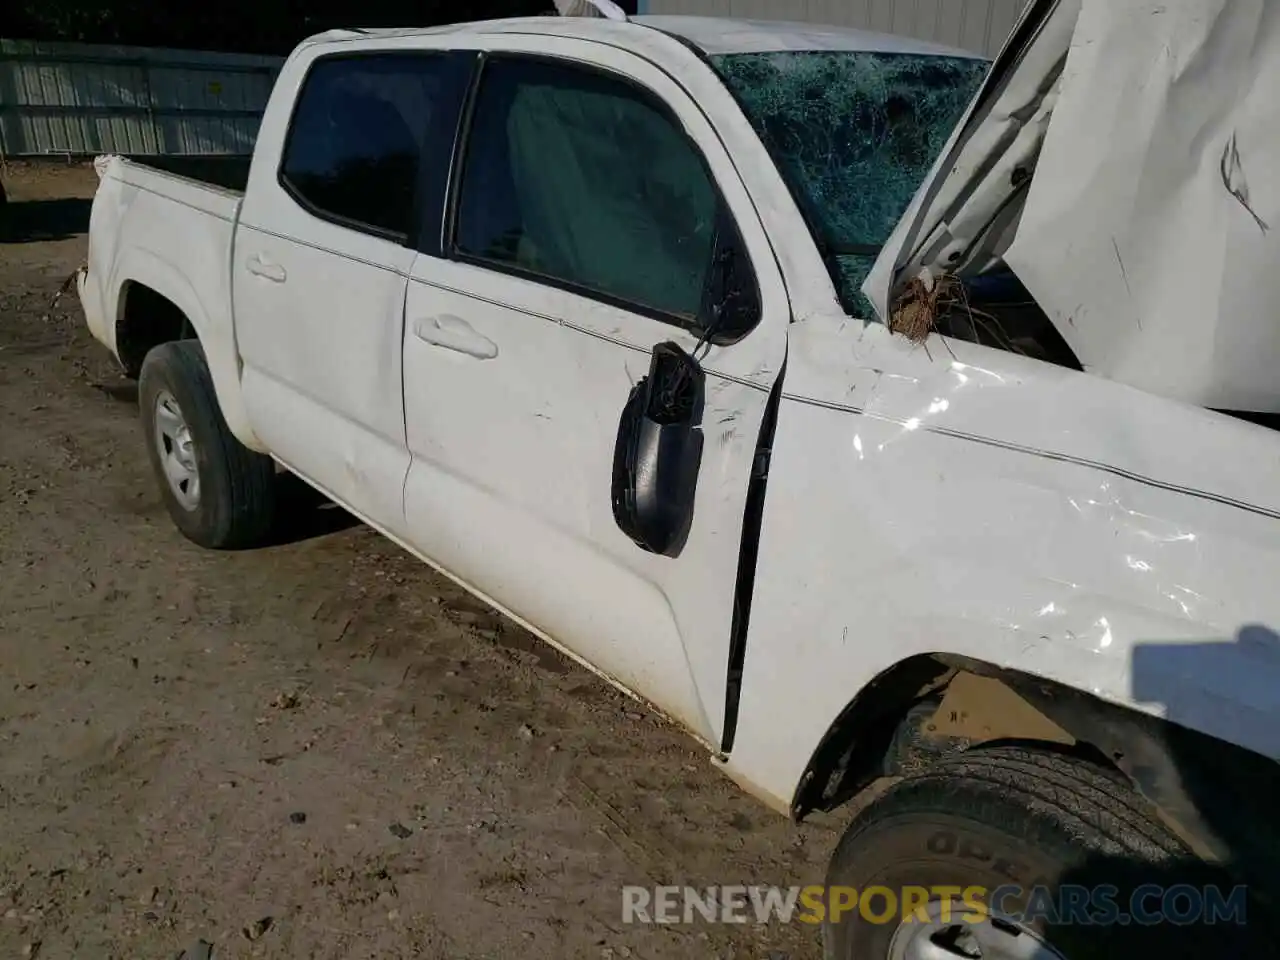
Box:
[452, 56, 719, 324]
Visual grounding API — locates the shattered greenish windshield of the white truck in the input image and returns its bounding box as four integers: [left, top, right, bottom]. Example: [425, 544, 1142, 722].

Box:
[710, 51, 989, 317]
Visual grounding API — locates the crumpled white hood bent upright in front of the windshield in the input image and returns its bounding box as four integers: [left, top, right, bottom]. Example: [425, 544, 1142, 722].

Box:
[863, 0, 1280, 411]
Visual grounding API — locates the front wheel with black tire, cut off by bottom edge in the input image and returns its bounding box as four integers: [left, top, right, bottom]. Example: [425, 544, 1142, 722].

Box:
[823, 746, 1268, 960]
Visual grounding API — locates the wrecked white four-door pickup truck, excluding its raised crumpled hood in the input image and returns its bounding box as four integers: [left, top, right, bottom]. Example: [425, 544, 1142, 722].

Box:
[78, 3, 1280, 960]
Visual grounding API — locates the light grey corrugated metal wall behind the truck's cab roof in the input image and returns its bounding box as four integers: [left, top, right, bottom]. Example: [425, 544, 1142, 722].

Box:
[641, 0, 1024, 56]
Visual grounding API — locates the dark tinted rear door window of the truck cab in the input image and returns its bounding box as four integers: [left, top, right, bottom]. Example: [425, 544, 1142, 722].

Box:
[280, 52, 475, 246]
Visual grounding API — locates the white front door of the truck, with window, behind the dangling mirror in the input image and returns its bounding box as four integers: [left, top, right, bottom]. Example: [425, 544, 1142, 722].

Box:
[404, 37, 790, 741]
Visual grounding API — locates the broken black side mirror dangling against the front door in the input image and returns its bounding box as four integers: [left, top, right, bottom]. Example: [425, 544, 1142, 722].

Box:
[613, 343, 705, 557]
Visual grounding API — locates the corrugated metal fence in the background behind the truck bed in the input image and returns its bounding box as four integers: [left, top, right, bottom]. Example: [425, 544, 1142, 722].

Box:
[0, 40, 283, 156]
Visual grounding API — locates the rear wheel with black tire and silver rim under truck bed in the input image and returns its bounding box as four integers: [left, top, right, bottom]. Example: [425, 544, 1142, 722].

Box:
[138, 340, 275, 549]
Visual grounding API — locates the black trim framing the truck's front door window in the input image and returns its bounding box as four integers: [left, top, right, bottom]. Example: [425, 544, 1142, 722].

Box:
[440, 50, 763, 342]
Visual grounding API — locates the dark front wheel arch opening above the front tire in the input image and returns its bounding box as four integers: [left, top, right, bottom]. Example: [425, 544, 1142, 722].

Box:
[792, 653, 1280, 881]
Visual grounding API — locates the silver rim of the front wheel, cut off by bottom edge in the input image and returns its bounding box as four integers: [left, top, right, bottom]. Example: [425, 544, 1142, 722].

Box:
[888, 900, 1065, 960]
